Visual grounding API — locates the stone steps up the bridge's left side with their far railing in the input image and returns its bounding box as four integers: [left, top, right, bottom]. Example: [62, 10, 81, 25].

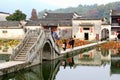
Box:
[10, 29, 41, 61]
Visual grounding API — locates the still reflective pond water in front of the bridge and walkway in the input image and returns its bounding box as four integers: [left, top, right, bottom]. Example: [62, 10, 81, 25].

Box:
[0, 49, 120, 80]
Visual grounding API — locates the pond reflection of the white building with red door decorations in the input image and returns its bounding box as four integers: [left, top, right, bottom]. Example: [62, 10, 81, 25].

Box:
[74, 50, 102, 66]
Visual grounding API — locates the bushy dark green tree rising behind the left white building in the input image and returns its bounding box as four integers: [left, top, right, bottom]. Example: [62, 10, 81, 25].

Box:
[6, 10, 26, 21]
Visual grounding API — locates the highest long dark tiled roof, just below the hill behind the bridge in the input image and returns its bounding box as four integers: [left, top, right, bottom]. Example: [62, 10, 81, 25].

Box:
[43, 12, 74, 20]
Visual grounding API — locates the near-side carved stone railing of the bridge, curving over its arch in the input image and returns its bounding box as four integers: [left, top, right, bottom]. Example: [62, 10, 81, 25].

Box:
[26, 29, 60, 63]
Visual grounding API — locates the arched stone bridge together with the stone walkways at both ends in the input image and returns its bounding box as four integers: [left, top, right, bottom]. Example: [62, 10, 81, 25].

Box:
[0, 29, 106, 75]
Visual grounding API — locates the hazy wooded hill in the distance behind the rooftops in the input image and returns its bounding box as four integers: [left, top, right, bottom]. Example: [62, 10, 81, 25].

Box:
[38, 1, 120, 19]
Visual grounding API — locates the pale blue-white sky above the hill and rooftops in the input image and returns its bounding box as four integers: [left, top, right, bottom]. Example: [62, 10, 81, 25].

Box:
[0, 0, 120, 17]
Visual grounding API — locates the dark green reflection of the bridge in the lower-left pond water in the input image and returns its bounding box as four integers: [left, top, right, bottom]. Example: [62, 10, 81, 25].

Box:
[0, 60, 61, 80]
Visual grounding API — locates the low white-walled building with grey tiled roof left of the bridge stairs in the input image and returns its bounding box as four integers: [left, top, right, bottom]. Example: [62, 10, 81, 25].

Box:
[0, 21, 25, 39]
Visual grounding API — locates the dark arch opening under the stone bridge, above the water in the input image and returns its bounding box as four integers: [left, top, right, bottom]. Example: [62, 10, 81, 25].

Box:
[42, 41, 52, 60]
